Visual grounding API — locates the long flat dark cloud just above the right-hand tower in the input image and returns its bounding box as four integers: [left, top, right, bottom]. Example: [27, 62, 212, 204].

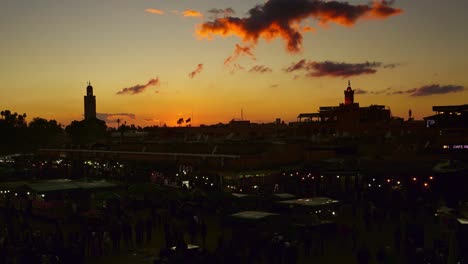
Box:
[284, 60, 382, 78]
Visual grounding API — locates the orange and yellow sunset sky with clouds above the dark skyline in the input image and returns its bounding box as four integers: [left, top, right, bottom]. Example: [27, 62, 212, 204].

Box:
[0, 0, 468, 126]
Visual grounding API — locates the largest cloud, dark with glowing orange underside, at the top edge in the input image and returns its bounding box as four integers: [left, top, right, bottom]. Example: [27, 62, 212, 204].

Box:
[196, 0, 403, 53]
